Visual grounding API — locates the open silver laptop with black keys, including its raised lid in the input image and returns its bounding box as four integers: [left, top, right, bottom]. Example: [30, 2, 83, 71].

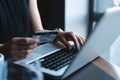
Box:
[15, 7, 120, 79]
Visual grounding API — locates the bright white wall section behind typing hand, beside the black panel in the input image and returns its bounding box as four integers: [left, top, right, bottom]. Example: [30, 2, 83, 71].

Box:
[65, 0, 88, 37]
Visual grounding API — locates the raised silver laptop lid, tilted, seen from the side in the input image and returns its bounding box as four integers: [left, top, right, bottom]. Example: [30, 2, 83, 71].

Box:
[63, 7, 120, 78]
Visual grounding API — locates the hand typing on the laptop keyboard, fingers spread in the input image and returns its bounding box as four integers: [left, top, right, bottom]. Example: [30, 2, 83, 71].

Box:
[55, 31, 85, 50]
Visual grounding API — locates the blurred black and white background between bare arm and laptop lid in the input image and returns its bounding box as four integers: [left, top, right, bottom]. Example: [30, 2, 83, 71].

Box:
[38, 0, 114, 37]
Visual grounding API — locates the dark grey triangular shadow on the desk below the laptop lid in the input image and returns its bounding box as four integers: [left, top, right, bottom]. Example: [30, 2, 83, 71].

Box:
[65, 61, 115, 80]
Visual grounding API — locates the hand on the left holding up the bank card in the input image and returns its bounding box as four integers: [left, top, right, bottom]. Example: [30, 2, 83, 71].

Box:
[2, 37, 39, 60]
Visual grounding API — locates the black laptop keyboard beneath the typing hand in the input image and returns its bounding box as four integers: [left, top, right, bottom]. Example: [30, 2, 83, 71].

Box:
[40, 48, 77, 71]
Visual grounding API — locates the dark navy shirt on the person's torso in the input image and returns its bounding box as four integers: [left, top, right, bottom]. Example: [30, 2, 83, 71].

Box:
[0, 0, 30, 43]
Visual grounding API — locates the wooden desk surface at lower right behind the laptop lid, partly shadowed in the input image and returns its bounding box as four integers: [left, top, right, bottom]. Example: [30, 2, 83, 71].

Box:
[65, 57, 120, 80]
